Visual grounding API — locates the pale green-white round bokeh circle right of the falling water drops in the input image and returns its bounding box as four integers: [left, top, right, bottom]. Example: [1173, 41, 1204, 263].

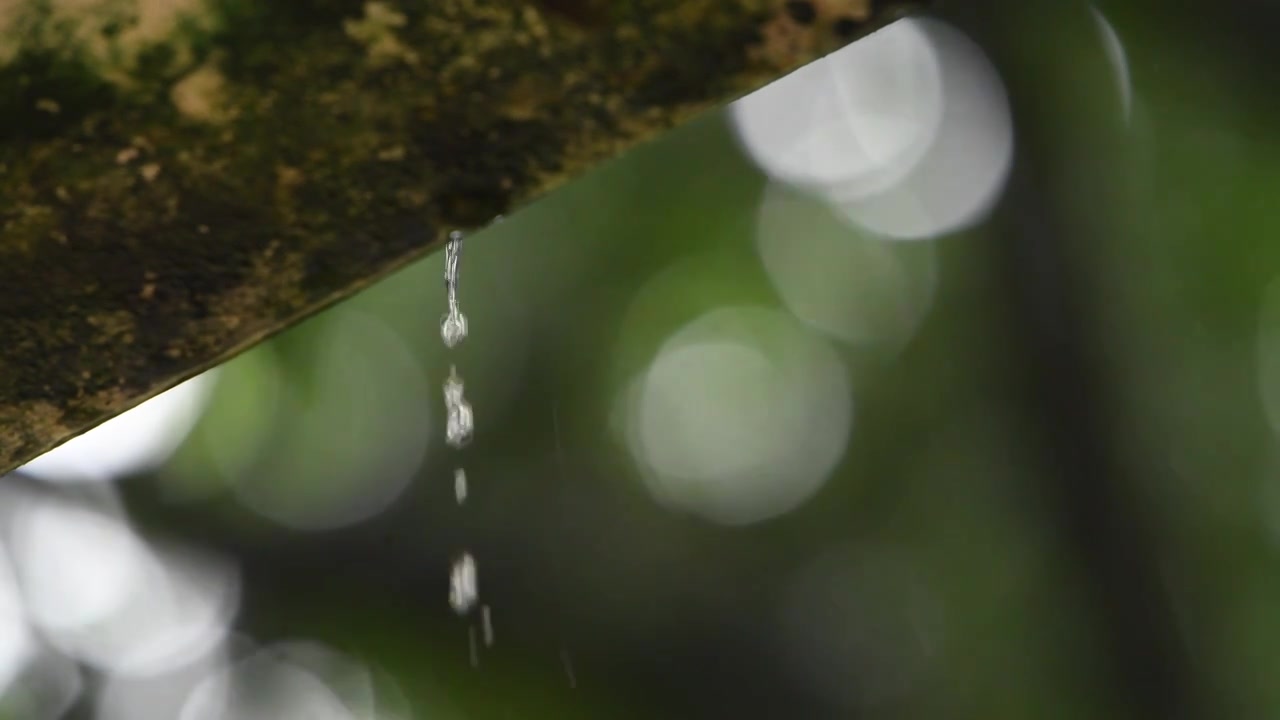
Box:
[618, 307, 852, 525]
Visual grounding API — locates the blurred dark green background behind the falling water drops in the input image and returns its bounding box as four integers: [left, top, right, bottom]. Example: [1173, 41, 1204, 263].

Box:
[8, 1, 1280, 720]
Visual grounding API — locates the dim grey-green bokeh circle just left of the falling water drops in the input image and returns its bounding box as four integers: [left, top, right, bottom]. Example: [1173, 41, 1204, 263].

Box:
[224, 304, 436, 530]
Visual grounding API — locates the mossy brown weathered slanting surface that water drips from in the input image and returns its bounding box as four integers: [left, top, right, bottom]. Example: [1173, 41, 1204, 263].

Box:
[0, 0, 922, 471]
